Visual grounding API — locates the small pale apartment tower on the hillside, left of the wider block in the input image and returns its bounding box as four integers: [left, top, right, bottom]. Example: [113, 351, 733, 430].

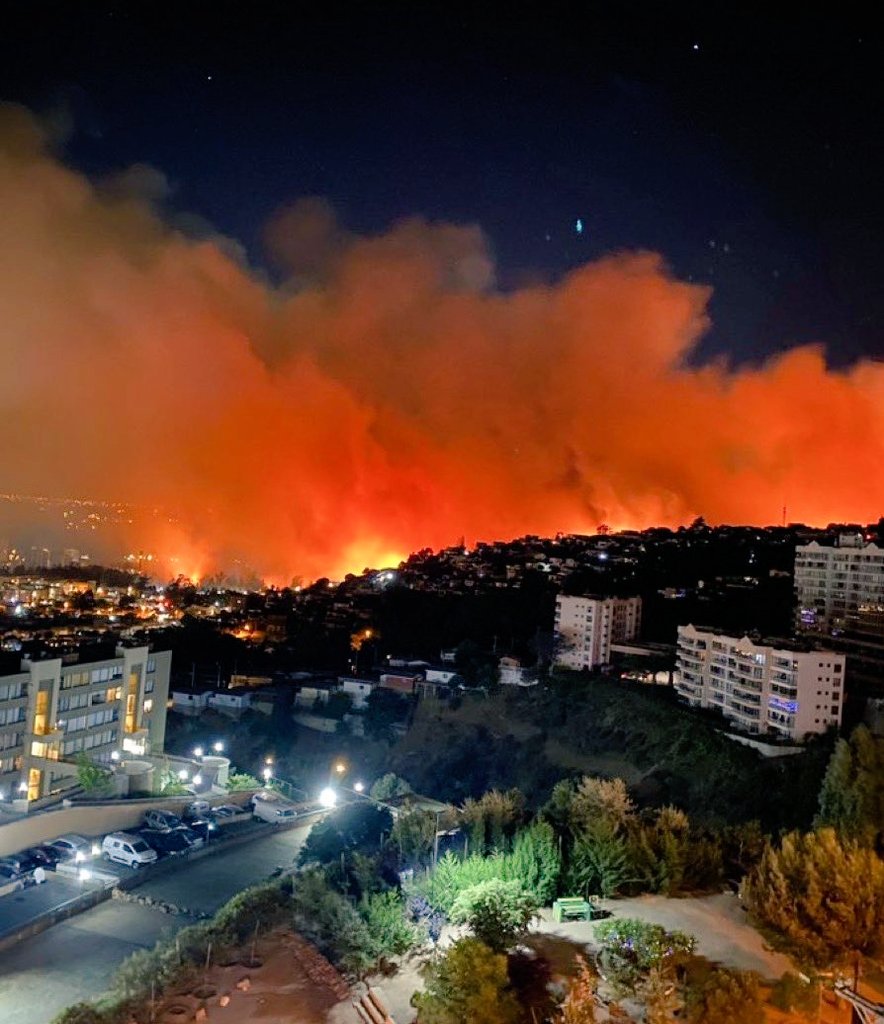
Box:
[555, 594, 641, 670]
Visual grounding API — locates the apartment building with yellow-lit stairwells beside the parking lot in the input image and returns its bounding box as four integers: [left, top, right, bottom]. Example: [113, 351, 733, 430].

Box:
[0, 647, 172, 801]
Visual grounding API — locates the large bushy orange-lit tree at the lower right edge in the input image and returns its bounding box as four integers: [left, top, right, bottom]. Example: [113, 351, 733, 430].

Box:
[742, 828, 884, 967]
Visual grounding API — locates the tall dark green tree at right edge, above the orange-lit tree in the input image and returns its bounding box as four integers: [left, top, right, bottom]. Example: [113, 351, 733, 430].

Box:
[813, 725, 884, 846]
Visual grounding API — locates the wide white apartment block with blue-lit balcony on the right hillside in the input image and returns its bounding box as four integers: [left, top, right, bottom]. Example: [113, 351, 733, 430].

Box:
[675, 626, 845, 739]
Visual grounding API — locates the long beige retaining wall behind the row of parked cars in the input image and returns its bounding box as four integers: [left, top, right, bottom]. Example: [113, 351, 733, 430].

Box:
[0, 791, 251, 856]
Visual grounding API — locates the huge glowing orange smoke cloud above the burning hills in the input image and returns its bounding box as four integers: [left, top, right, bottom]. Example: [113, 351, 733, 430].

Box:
[0, 108, 884, 581]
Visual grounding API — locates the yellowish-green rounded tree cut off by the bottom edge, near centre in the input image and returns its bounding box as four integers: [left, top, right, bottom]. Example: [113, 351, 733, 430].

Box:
[412, 938, 522, 1024]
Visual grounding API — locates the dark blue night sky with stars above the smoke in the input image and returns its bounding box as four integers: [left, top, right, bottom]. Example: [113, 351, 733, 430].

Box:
[0, 0, 884, 365]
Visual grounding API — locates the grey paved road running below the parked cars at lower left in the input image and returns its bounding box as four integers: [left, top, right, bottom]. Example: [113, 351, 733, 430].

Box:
[0, 824, 309, 1024]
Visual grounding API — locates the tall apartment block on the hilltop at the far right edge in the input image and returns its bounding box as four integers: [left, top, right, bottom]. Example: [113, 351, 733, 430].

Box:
[795, 534, 884, 633]
